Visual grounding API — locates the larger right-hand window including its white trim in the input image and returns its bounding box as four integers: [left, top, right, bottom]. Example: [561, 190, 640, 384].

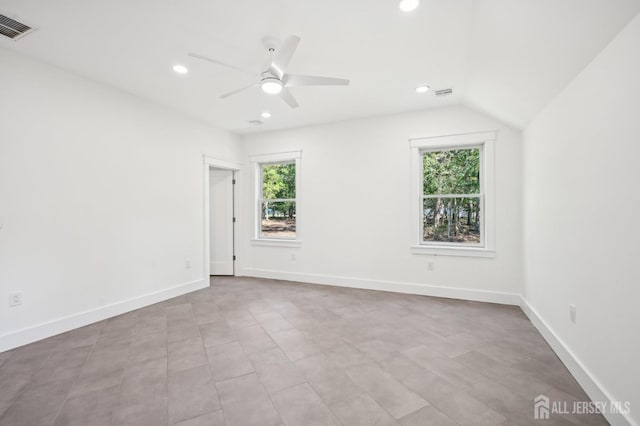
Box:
[411, 132, 495, 257]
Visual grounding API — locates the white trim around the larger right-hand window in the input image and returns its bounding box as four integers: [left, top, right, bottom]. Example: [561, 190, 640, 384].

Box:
[409, 130, 497, 257]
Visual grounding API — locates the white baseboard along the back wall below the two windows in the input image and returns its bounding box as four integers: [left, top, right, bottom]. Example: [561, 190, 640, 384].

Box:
[241, 268, 520, 306]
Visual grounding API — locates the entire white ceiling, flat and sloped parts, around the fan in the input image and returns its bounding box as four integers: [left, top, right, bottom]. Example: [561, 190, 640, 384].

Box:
[0, 0, 640, 133]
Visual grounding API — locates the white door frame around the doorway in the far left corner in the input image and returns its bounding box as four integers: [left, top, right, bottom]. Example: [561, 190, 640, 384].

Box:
[202, 155, 242, 280]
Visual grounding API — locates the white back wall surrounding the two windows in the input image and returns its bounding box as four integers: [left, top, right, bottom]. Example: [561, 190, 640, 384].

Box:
[239, 107, 522, 303]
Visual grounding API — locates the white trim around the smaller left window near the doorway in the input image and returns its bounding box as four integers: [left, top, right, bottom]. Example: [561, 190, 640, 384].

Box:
[249, 151, 302, 247]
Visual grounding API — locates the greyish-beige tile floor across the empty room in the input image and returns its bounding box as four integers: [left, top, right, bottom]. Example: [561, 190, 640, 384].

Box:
[0, 277, 607, 426]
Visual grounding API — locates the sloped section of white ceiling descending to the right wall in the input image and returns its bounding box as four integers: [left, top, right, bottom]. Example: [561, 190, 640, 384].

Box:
[464, 0, 640, 128]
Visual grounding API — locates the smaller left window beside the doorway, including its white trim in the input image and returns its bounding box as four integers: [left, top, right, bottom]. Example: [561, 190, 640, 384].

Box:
[252, 152, 300, 245]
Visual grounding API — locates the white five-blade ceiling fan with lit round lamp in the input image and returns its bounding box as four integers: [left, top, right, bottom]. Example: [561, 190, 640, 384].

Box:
[189, 36, 349, 108]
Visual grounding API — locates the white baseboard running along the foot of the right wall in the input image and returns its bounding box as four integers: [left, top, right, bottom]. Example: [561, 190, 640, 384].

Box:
[520, 297, 638, 426]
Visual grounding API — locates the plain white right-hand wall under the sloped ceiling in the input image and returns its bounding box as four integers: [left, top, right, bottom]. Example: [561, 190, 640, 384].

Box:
[523, 16, 640, 424]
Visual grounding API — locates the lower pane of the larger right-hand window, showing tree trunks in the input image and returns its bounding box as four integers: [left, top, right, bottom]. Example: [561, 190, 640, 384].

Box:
[422, 198, 480, 244]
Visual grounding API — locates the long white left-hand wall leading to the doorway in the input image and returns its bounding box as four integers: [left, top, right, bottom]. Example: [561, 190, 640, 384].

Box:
[0, 49, 240, 351]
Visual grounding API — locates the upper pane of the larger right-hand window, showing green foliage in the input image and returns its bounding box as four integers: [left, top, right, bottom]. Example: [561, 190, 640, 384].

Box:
[422, 148, 480, 195]
